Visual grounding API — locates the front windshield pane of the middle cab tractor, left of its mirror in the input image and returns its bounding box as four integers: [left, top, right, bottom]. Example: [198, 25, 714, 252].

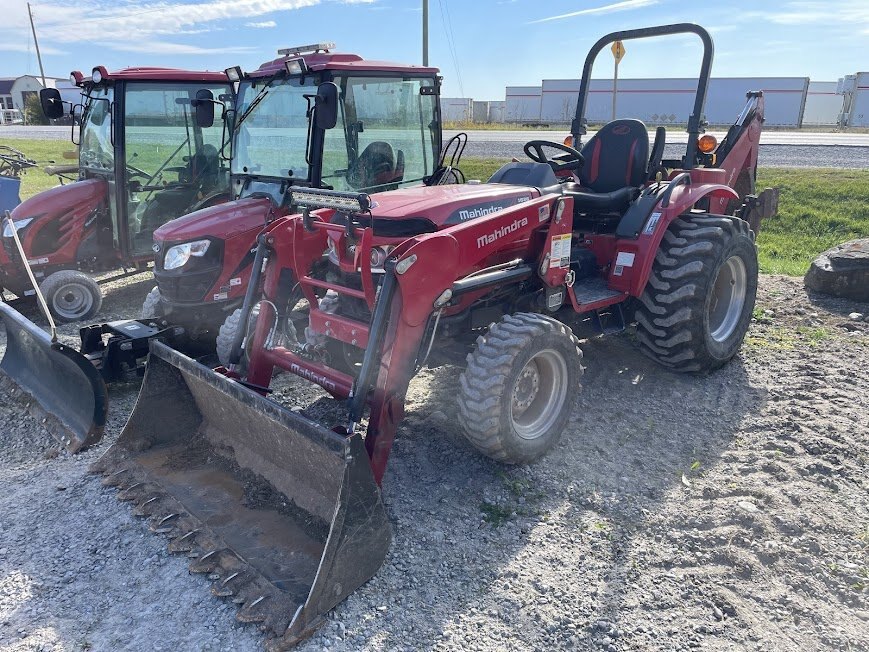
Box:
[232, 78, 317, 179]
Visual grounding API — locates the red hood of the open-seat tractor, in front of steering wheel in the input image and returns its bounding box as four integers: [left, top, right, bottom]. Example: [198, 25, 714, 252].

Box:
[371, 183, 540, 227]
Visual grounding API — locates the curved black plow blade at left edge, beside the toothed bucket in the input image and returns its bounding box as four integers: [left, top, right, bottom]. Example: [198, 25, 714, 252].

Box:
[0, 302, 108, 453]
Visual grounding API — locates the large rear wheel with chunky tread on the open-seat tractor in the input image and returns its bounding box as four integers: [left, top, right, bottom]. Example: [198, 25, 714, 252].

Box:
[635, 214, 758, 373]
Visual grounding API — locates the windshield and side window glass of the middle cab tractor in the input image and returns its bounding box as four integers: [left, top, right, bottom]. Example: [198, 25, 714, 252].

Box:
[232, 76, 440, 191]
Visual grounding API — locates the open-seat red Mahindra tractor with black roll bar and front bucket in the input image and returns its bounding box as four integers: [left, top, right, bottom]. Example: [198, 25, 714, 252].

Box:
[94, 24, 762, 650]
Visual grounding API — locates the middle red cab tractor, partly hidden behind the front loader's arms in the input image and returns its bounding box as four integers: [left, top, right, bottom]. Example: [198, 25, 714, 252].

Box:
[142, 43, 464, 363]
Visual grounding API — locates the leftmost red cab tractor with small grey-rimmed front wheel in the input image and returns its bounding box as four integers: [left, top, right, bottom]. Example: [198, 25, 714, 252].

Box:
[0, 66, 232, 321]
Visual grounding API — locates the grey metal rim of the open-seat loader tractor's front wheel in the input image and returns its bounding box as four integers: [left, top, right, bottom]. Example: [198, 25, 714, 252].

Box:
[510, 349, 567, 439]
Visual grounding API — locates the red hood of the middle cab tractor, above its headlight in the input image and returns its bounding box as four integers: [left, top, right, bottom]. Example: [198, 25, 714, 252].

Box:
[154, 197, 272, 243]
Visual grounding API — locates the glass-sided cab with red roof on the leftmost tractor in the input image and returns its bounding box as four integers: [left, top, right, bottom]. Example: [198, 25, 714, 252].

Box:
[64, 66, 232, 261]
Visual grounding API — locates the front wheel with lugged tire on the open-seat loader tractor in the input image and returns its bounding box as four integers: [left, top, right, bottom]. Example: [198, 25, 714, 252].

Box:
[458, 313, 582, 464]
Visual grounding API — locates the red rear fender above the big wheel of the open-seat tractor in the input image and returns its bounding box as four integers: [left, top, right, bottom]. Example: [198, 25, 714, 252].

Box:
[608, 183, 739, 297]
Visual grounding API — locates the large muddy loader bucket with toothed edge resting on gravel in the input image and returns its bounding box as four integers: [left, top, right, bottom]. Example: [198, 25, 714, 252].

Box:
[92, 341, 391, 650]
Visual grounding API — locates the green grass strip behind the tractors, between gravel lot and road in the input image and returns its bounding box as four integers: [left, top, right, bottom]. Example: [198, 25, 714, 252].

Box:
[2, 139, 869, 276]
